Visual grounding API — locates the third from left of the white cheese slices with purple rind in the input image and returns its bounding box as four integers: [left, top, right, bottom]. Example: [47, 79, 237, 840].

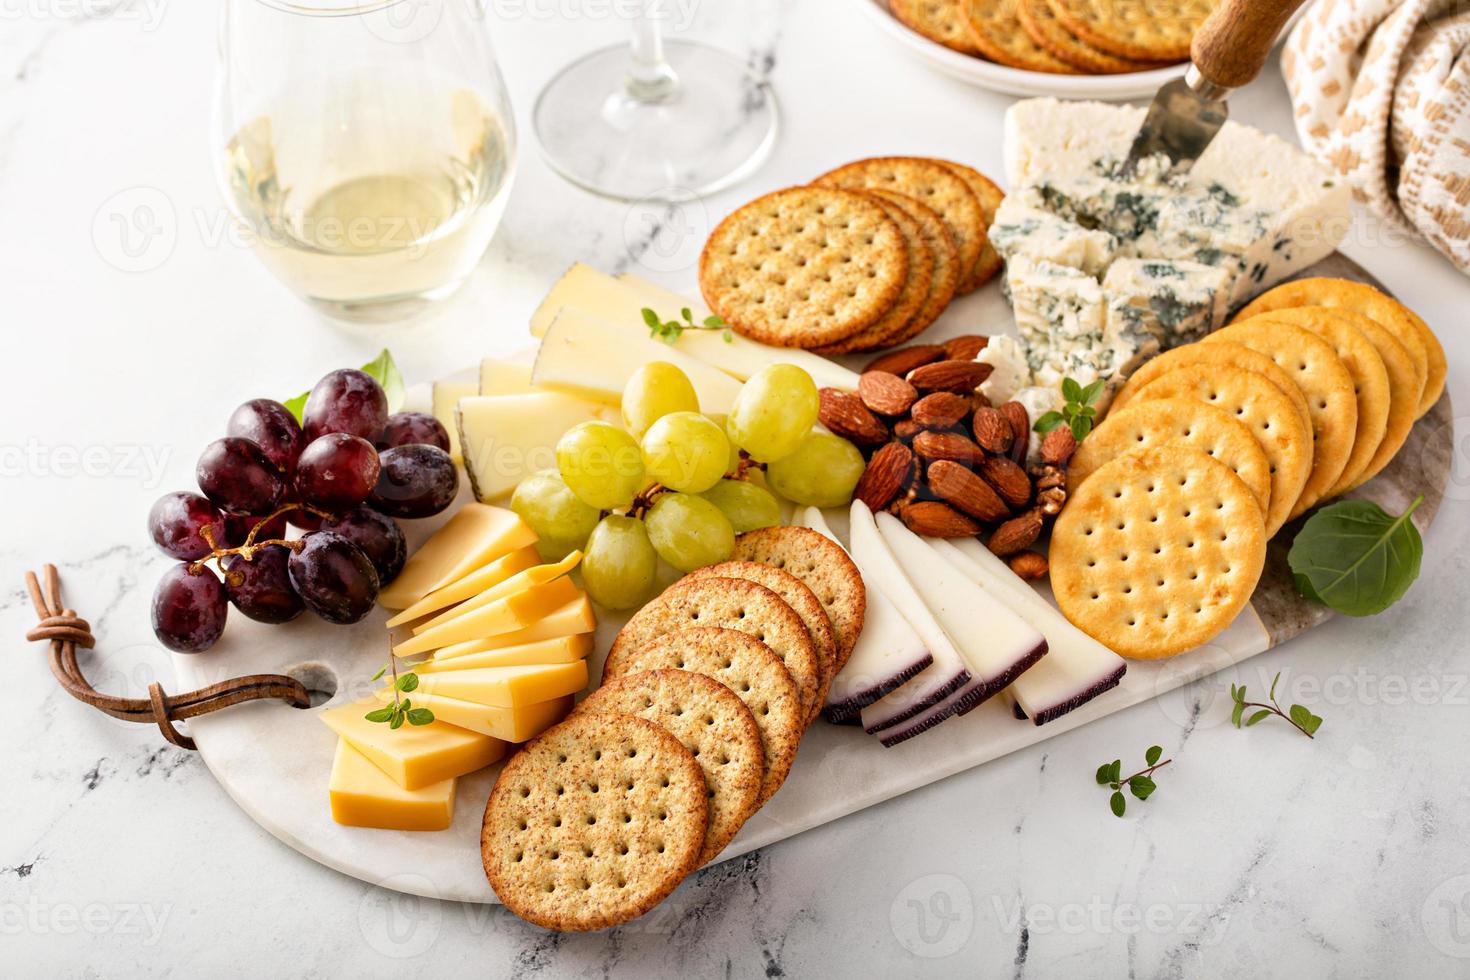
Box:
[878, 513, 1047, 714]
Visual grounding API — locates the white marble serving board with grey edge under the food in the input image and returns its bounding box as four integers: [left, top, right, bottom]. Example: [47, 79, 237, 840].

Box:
[173, 256, 1454, 904]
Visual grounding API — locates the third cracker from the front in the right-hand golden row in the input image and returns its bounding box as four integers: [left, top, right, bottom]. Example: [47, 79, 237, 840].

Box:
[1128, 364, 1313, 538]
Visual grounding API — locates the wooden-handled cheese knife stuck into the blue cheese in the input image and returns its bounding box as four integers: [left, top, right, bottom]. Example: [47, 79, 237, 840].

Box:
[1123, 0, 1304, 175]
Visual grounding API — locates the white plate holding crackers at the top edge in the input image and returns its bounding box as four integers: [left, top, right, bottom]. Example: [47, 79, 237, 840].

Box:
[856, 0, 1302, 101]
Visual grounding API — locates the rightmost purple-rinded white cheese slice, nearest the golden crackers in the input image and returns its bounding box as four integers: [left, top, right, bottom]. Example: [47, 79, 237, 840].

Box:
[931, 538, 1127, 724]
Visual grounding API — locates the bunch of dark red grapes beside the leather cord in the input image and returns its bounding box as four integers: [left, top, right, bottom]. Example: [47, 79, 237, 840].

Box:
[148, 370, 459, 654]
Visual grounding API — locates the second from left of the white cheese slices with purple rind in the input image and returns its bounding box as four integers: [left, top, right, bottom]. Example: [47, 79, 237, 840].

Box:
[850, 500, 970, 733]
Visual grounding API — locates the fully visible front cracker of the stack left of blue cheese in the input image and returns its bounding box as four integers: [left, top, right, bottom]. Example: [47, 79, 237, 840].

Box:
[700, 187, 908, 347]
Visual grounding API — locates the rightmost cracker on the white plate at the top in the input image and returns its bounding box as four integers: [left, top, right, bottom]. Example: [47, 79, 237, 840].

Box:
[1050, 0, 1219, 62]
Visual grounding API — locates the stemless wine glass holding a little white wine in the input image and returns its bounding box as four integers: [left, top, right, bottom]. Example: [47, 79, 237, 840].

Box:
[215, 0, 516, 322]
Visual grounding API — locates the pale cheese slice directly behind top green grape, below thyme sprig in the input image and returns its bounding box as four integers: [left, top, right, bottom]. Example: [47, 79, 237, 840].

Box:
[531, 307, 739, 414]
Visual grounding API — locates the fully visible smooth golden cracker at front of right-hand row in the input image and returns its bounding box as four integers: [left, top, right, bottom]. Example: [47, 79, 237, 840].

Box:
[1050, 445, 1266, 660]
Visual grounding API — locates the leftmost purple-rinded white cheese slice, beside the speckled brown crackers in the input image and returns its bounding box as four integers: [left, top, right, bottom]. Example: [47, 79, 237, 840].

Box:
[801, 507, 933, 724]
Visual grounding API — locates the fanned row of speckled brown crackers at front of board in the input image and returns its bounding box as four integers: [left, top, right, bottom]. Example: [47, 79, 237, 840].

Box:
[481, 527, 867, 932]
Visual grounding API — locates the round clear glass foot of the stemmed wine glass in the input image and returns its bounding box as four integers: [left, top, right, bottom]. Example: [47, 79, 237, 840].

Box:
[534, 41, 779, 201]
